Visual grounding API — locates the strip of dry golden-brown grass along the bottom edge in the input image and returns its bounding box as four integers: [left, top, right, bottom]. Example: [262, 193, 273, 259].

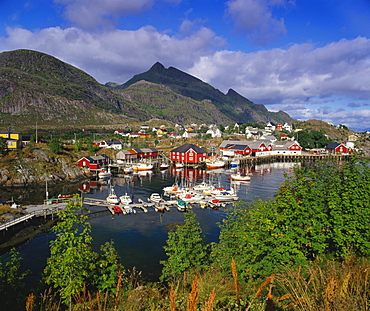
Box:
[19, 258, 370, 311]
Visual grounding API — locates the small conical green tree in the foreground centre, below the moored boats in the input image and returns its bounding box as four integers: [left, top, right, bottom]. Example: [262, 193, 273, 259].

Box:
[161, 212, 209, 280]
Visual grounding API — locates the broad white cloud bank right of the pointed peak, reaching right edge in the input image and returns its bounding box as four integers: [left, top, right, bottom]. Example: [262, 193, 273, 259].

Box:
[189, 37, 370, 104]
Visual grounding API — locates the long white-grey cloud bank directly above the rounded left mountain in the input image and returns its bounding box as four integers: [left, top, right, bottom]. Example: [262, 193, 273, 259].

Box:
[0, 26, 222, 83]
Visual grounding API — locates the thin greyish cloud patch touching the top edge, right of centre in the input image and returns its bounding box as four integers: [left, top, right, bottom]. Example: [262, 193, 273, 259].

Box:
[226, 0, 287, 45]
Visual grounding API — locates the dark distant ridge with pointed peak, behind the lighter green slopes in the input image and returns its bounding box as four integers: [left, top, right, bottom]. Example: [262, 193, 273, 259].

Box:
[109, 62, 292, 123]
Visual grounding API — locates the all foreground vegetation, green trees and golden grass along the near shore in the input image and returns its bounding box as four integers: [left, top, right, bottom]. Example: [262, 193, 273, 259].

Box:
[0, 157, 370, 311]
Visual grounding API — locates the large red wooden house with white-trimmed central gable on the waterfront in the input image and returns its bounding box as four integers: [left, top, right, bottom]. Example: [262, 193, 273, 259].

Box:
[170, 144, 207, 164]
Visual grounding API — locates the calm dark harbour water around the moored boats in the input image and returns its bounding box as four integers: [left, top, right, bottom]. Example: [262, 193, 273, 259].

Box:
[5, 163, 294, 283]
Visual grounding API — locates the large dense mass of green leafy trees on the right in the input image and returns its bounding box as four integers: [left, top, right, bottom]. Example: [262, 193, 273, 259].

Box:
[212, 157, 370, 279]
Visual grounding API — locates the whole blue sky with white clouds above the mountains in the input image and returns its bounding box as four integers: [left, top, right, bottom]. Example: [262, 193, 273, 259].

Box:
[0, 0, 370, 132]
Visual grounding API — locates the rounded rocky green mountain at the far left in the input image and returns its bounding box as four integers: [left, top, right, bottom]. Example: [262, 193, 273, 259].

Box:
[0, 50, 134, 124]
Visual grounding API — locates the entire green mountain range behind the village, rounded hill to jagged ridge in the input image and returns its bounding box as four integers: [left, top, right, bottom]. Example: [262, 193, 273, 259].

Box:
[0, 50, 291, 130]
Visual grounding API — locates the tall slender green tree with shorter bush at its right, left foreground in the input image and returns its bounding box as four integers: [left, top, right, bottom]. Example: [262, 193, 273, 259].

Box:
[44, 201, 124, 310]
